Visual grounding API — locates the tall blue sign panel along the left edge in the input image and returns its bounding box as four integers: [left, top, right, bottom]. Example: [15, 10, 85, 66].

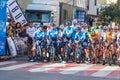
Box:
[0, 0, 7, 55]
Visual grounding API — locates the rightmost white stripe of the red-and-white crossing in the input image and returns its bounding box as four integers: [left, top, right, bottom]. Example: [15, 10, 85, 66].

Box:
[91, 66, 119, 77]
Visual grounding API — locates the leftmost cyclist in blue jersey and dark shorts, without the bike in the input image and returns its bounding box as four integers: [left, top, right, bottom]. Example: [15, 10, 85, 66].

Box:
[30, 24, 46, 62]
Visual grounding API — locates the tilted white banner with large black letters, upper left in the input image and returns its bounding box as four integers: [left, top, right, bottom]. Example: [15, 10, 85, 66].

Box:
[7, 0, 27, 25]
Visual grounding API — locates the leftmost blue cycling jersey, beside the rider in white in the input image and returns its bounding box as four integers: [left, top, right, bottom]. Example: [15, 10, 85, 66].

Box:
[33, 30, 46, 41]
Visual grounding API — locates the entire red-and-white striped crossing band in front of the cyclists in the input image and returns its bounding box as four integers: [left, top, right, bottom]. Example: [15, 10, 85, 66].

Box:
[0, 61, 120, 79]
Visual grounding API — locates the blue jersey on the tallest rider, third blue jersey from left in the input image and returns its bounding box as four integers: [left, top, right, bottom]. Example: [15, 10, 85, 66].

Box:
[63, 27, 75, 39]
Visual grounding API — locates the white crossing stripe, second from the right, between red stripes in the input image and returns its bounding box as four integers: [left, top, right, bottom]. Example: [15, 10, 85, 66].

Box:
[60, 64, 93, 74]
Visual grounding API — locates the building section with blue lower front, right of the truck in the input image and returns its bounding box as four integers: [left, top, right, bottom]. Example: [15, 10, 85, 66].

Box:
[63, 0, 87, 23]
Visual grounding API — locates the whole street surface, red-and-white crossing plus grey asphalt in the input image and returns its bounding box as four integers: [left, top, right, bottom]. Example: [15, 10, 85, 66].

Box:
[0, 57, 120, 80]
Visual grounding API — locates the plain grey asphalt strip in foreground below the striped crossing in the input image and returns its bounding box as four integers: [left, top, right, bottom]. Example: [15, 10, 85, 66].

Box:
[0, 71, 119, 80]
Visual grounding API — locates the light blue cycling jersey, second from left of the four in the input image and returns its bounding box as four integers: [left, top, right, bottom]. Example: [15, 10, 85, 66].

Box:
[47, 28, 58, 40]
